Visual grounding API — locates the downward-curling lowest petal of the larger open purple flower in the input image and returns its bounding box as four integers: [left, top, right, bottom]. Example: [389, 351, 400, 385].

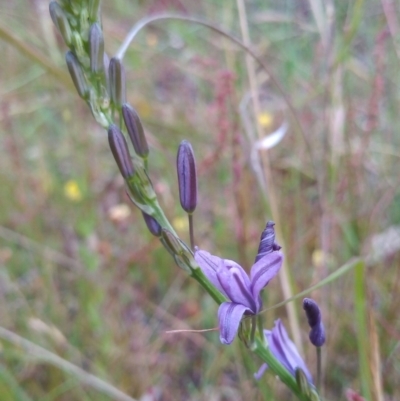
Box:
[218, 302, 249, 344]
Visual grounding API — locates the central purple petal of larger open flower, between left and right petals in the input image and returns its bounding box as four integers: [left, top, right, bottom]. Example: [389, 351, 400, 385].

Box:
[217, 261, 256, 313]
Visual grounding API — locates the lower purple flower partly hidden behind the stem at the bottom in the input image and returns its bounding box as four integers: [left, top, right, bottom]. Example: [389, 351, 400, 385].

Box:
[254, 319, 313, 384]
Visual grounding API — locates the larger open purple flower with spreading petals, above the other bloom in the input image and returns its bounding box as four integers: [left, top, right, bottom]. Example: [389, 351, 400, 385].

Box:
[194, 248, 283, 344]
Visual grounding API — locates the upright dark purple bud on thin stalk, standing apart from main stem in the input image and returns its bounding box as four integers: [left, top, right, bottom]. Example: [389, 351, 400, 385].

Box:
[176, 141, 197, 213]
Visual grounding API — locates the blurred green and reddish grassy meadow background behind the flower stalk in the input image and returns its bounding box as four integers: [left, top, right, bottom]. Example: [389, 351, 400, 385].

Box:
[0, 0, 400, 401]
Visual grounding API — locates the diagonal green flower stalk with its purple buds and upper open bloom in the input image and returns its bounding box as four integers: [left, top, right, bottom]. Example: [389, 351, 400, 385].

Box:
[50, 0, 324, 401]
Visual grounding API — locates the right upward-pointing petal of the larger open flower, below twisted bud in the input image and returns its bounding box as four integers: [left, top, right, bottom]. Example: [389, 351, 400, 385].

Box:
[250, 252, 283, 306]
